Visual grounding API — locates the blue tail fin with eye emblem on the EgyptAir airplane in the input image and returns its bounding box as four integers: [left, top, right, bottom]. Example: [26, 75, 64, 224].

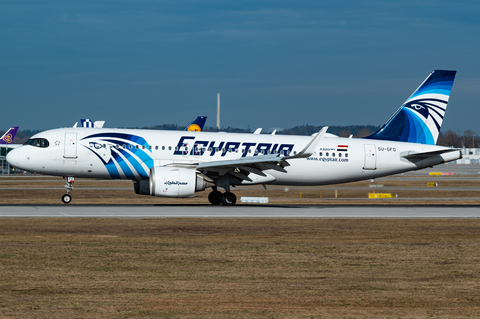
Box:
[365, 70, 457, 145]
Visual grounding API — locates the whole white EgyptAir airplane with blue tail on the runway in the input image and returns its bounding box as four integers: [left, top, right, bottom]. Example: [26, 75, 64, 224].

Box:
[7, 70, 462, 206]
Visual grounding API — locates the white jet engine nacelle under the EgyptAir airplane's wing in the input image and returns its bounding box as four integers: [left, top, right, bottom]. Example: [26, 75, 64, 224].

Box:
[150, 167, 206, 197]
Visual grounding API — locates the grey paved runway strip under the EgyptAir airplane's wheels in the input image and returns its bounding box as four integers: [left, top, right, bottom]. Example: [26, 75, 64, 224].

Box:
[0, 205, 480, 219]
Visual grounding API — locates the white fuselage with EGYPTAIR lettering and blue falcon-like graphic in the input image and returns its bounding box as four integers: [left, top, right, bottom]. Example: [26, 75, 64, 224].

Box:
[7, 128, 461, 185]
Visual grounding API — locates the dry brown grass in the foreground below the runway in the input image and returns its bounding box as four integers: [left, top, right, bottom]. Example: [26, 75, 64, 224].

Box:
[0, 219, 480, 318]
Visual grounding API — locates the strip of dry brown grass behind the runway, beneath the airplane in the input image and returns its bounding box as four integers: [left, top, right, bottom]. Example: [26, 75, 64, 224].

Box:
[0, 176, 480, 205]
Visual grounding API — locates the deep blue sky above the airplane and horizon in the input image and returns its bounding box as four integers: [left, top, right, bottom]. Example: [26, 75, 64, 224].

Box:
[0, 0, 480, 133]
